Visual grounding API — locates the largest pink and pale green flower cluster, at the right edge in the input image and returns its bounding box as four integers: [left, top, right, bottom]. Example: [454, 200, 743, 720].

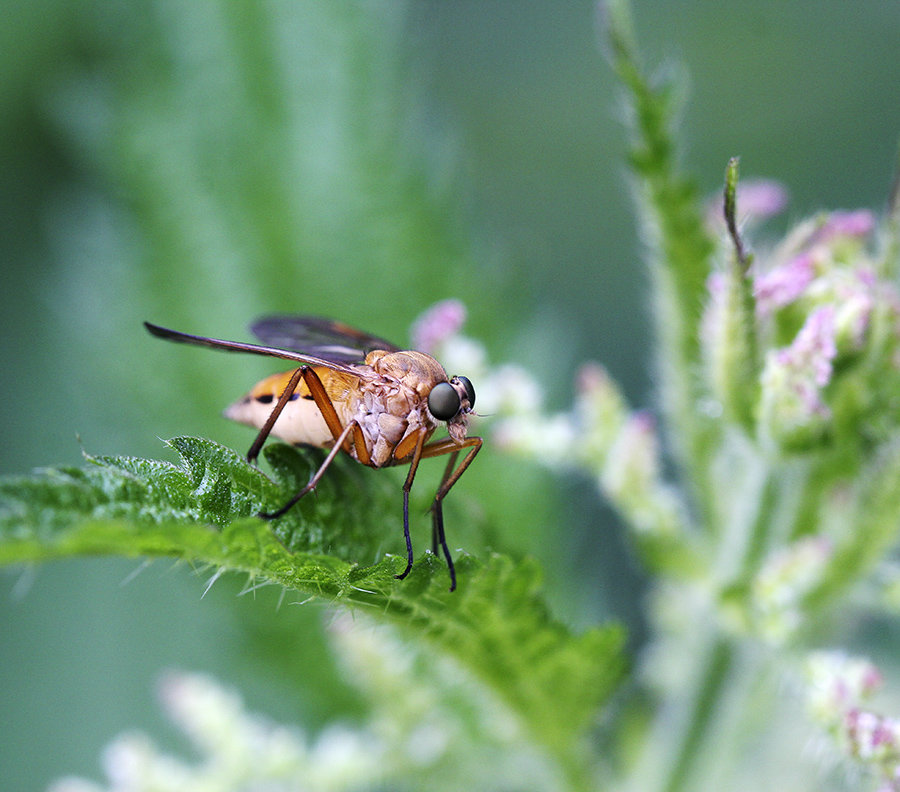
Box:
[701, 185, 900, 451]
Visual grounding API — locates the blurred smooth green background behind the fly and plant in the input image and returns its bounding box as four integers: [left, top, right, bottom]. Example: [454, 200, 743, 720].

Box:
[0, 0, 900, 789]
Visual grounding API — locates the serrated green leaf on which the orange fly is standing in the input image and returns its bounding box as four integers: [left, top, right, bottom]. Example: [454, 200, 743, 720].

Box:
[0, 437, 624, 764]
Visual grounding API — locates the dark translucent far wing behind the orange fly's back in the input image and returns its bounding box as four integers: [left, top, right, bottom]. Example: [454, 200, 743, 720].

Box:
[250, 316, 400, 363]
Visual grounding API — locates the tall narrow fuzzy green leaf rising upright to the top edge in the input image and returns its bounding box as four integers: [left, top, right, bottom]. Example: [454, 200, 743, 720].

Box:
[605, 0, 717, 528]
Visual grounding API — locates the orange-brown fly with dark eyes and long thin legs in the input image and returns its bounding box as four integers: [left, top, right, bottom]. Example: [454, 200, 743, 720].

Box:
[144, 316, 482, 591]
